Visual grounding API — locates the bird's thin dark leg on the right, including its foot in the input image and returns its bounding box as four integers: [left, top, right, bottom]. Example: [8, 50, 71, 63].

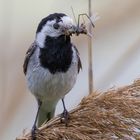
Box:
[61, 99, 69, 126]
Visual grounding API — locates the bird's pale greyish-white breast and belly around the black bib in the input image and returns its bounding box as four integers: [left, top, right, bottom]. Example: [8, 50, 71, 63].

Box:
[26, 48, 78, 101]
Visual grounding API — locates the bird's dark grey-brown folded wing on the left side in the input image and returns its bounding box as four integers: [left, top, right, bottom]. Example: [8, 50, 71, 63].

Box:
[23, 42, 37, 75]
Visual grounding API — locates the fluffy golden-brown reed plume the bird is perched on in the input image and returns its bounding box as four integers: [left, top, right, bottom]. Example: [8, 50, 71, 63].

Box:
[17, 80, 140, 140]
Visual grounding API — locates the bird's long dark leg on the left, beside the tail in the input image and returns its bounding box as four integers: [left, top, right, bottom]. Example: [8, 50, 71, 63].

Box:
[31, 100, 42, 140]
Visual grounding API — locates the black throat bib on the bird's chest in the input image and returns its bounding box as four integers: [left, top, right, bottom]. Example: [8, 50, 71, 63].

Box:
[39, 35, 72, 74]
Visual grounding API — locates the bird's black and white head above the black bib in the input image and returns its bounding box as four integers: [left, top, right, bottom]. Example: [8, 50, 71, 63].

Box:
[36, 13, 74, 45]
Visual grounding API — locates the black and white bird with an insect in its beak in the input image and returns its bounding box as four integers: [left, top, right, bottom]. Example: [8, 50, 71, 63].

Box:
[23, 13, 81, 136]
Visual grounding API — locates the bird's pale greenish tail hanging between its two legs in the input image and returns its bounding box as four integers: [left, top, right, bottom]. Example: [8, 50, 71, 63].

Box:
[38, 101, 57, 127]
